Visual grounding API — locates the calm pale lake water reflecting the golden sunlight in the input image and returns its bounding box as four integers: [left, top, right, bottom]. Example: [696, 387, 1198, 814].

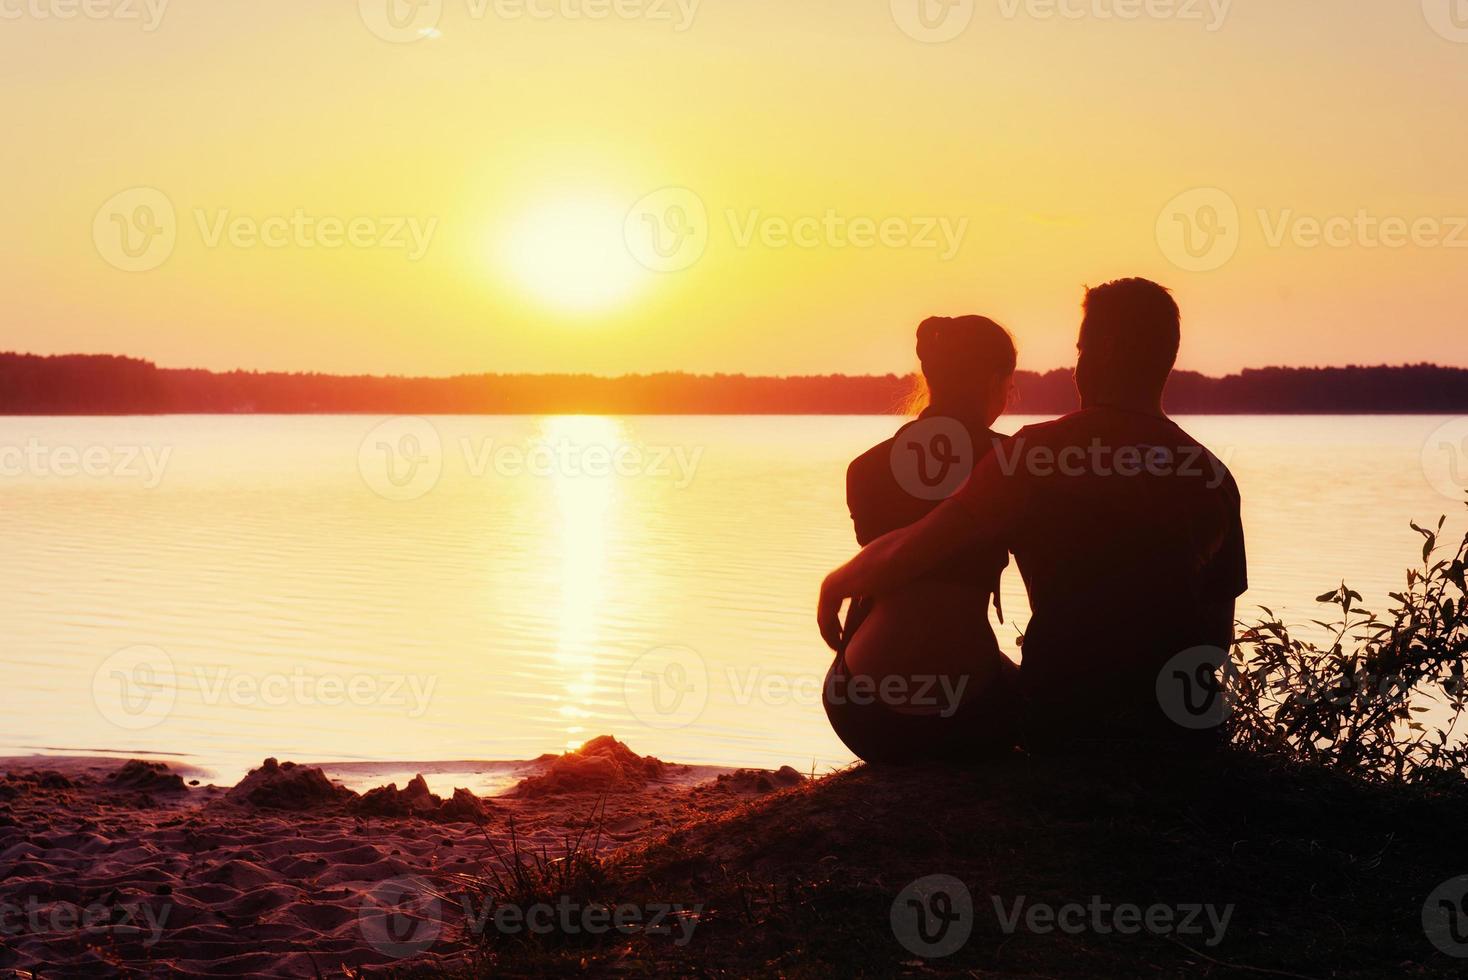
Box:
[0, 417, 1468, 779]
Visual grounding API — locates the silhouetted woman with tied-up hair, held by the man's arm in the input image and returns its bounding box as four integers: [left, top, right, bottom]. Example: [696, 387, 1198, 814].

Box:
[824, 317, 1019, 764]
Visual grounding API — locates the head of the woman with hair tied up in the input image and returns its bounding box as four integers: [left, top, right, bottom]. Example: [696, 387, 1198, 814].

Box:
[918, 317, 1019, 425]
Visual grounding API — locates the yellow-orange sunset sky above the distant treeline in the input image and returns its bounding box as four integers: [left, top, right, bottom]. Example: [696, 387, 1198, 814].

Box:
[0, 0, 1468, 374]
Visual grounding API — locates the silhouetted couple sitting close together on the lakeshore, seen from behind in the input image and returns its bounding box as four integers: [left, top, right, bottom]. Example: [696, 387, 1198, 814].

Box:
[818, 279, 1246, 764]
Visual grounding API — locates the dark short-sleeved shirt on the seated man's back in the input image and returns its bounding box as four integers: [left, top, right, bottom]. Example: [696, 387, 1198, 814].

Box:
[954, 408, 1248, 729]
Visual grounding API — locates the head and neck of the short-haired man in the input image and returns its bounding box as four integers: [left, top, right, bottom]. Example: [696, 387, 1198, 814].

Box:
[1076, 279, 1180, 409]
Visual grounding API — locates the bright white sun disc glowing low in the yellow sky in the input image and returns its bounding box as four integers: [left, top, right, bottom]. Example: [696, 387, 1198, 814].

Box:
[501, 200, 646, 311]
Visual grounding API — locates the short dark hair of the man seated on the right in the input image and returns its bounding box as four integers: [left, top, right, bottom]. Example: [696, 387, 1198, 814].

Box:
[1080, 279, 1182, 387]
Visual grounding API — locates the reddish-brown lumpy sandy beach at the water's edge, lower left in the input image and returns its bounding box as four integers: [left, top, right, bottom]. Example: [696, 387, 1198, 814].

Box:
[0, 738, 803, 977]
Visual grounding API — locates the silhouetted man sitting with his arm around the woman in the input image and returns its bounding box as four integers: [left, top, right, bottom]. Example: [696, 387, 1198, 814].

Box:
[818, 279, 1248, 744]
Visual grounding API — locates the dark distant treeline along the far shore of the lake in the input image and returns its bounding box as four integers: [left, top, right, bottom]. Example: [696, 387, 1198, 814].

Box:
[0, 354, 1468, 415]
